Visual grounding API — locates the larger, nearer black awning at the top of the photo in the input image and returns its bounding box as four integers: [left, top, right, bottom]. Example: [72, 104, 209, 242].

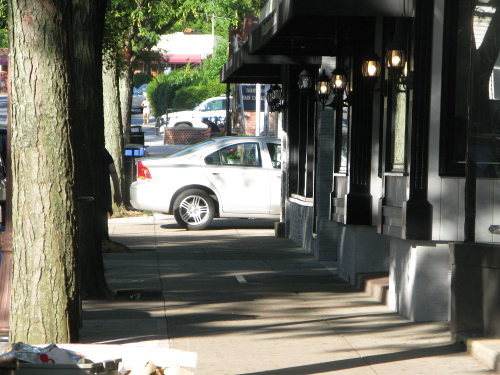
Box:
[248, 0, 416, 56]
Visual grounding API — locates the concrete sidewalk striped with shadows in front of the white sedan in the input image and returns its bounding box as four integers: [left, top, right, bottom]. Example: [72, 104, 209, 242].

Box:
[81, 216, 496, 375]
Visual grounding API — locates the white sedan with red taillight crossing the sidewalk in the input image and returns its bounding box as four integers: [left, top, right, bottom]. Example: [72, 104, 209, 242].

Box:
[130, 137, 281, 230]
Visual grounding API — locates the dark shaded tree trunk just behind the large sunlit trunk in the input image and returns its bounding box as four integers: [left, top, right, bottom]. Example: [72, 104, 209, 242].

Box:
[72, 0, 112, 298]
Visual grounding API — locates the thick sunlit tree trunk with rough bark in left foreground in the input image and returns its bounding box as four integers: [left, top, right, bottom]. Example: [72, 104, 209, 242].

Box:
[9, 0, 79, 344]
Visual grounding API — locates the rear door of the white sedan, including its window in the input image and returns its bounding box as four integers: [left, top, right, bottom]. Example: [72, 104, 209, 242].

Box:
[202, 142, 271, 215]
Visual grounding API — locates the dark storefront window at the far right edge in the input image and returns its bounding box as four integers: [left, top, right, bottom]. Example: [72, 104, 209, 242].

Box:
[440, 0, 500, 177]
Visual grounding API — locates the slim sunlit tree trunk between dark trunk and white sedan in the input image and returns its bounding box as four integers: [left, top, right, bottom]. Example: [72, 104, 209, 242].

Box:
[102, 59, 125, 201]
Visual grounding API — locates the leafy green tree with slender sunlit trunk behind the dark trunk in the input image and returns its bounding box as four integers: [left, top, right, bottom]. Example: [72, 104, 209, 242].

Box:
[103, 0, 259, 201]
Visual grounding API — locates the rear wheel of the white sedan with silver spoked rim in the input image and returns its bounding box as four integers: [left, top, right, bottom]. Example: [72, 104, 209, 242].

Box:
[174, 189, 215, 230]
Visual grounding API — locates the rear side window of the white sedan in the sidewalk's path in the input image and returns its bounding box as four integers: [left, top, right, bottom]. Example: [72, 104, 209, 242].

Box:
[205, 143, 262, 167]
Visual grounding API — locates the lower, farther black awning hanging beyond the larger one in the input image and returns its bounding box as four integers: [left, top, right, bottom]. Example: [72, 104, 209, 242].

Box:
[220, 43, 321, 83]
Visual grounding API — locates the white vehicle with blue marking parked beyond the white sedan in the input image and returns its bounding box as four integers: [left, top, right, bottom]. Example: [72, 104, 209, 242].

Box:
[162, 96, 226, 128]
